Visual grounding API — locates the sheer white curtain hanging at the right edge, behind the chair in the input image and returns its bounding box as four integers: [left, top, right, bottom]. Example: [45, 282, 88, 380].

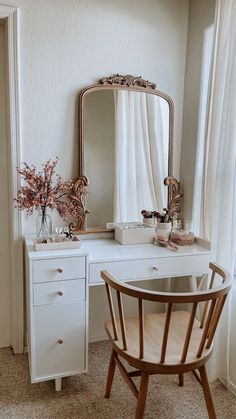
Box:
[194, 0, 236, 384]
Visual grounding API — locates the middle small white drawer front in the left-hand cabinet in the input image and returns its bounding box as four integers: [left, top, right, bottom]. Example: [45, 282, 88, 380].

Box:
[34, 279, 86, 306]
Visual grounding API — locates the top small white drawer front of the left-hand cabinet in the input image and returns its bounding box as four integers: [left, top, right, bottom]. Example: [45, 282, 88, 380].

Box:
[33, 257, 85, 283]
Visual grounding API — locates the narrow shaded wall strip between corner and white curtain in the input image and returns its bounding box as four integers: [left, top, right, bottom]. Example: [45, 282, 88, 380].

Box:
[180, 0, 215, 220]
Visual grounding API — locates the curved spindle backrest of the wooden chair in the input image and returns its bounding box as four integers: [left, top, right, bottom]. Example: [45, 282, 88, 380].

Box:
[101, 263, 231, 364]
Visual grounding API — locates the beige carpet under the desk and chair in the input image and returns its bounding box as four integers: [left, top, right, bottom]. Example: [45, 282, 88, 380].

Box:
[0, 342, 236, 419]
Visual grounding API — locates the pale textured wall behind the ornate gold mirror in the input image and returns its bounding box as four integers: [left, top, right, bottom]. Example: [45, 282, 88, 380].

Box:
[1, 0, 188, 338]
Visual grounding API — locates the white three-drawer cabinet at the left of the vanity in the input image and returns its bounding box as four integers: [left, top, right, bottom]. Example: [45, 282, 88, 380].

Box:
[26, 243, 88, 390]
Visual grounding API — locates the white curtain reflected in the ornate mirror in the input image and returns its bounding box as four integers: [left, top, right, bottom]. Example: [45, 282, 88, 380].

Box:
[114, 90, 169, 222]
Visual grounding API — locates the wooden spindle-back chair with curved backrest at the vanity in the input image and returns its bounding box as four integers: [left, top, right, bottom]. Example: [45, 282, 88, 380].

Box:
[101, 263, 231, 419]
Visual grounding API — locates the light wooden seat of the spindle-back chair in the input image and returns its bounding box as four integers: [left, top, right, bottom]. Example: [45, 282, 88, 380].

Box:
[105, 311, 212, 366]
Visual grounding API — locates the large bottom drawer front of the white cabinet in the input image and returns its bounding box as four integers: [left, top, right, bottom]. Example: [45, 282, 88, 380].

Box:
[32, 302, 87, 380]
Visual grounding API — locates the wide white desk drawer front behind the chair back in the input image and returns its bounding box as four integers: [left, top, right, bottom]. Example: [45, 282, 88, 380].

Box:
[89, 255, 209, 284]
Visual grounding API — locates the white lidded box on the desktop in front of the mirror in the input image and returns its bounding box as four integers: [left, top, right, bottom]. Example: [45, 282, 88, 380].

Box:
[115, 222, 155, 244]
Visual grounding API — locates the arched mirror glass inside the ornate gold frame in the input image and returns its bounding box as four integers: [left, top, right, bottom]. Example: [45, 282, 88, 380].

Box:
[83, 87, 170, 227]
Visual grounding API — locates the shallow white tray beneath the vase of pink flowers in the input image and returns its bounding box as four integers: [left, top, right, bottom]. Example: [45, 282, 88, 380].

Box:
[34, 236, 81, 251]
